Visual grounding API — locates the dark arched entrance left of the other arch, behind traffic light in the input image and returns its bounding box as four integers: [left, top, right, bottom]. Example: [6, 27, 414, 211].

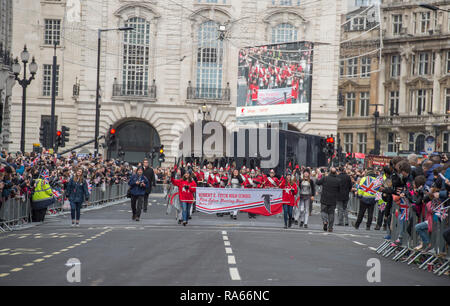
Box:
[108, 120, 161, 167]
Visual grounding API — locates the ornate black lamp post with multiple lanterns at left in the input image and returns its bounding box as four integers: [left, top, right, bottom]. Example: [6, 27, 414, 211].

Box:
[12, 45, 38, 154]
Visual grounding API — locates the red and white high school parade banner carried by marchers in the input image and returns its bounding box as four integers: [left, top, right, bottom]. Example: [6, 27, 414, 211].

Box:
[195, 187, 282, 216]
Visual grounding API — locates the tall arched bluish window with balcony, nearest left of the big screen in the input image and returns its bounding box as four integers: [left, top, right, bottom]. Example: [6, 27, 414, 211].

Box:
[197, 21, 224, 99]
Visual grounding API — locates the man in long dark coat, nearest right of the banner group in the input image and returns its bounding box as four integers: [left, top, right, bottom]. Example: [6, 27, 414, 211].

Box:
[317, 167, 341, 232]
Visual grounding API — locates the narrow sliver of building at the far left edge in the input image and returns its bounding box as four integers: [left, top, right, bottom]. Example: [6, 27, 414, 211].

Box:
[0, 0, 15, 150]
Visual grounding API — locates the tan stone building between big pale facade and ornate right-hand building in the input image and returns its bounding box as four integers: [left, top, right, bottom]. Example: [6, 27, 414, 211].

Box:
[337, 6, 381, 154]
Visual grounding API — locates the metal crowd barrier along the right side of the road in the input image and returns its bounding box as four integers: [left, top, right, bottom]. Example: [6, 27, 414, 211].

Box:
[376, 202, 450, 275]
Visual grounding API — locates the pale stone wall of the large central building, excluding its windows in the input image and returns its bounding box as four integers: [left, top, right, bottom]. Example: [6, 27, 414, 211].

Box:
[11, 0, 346, 159]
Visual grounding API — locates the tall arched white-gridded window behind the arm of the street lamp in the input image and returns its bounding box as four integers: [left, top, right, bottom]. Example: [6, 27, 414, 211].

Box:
[122, 17, 150, 96]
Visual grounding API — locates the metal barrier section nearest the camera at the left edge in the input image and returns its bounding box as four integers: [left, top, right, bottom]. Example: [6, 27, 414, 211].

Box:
[0, 197, 31, 232]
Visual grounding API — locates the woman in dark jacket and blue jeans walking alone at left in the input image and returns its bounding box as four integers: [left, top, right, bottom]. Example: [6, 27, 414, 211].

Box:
[66, 169, 89, 226]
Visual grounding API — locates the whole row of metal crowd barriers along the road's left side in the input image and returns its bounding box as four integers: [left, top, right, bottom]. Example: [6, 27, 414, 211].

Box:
[0, 182, 128, 232]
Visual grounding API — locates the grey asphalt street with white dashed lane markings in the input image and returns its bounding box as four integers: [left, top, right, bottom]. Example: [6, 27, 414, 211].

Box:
[0, 195, 450, 286]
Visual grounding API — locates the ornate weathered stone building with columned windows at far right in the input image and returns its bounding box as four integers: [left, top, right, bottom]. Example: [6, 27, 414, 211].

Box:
[380, 0, 450, 153]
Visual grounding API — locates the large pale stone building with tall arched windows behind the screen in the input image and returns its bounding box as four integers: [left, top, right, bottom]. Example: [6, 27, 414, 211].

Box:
[11, 0, 345, 162]
